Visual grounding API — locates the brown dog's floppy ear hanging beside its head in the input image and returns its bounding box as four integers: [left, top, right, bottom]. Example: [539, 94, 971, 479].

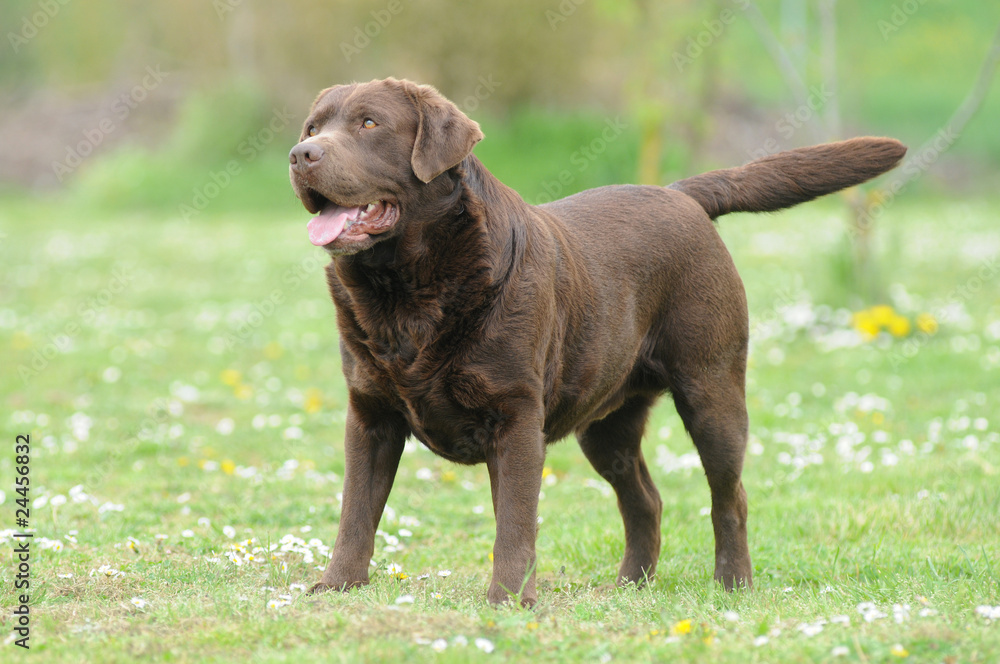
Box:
[404, 81, 483, 182]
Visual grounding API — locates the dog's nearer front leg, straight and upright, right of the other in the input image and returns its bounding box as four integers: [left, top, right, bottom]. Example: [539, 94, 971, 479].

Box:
[486, 404, 545, 606]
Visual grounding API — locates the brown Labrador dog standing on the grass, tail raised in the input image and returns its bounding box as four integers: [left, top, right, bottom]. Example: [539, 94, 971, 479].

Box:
[289, 78, 906, 604]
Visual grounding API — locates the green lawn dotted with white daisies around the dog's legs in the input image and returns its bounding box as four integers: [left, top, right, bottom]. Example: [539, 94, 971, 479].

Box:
[0, 193, 1000, 663]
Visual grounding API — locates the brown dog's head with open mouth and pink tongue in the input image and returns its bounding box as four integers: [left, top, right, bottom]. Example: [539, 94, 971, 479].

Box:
[288, 78, 483, 254]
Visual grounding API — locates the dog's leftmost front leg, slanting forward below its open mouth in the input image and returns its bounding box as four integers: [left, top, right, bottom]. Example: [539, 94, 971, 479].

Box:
[310, 395, 409, 592]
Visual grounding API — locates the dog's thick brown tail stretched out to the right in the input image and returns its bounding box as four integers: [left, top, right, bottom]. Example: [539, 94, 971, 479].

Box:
[669, 137, 906, 219]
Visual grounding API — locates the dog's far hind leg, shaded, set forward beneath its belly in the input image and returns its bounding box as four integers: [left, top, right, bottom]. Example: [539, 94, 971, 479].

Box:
[579, 396, 663, 585]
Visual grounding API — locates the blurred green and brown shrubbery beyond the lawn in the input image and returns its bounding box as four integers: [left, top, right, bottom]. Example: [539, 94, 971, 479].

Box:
[0, 0, 1000, 208]
